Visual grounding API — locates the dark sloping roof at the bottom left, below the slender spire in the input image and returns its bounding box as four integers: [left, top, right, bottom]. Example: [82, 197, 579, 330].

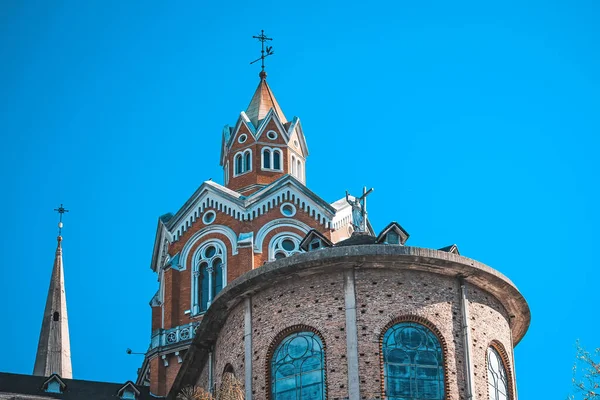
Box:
[0, 372, 157, 400]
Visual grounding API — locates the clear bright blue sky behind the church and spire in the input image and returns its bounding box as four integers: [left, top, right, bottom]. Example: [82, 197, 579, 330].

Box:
[0, 0, 600, 399]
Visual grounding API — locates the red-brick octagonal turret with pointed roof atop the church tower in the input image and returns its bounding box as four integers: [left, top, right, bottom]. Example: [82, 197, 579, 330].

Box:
[221, 72, 308, 195]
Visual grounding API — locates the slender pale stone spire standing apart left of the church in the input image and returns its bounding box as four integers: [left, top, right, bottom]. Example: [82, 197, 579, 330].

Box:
[33, 204, 73, 379]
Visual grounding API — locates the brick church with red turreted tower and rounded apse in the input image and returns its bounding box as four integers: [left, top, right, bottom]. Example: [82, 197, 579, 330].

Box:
[137, 32, 530, 400]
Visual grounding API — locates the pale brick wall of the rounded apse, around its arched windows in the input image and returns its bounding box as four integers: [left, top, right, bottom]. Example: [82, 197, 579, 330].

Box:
[202, 268, 512, 400]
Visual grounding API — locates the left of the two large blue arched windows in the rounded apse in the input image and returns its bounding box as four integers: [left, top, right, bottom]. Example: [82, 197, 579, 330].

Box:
[270, 332, 325, 400]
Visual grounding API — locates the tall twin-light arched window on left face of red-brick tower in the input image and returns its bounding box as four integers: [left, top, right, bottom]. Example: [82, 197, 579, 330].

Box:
[192, 242, 227, 314]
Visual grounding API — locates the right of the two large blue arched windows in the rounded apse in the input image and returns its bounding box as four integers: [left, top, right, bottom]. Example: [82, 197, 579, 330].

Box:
[382, 322, 444, 400]
